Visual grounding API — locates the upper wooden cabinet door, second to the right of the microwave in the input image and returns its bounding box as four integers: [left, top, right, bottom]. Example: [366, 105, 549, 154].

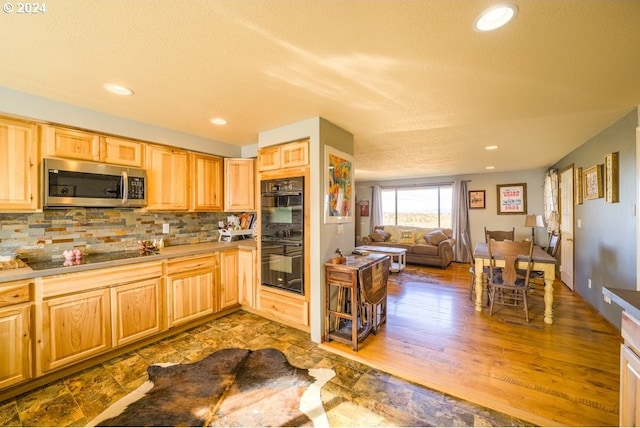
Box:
[189, 153, 222, 211]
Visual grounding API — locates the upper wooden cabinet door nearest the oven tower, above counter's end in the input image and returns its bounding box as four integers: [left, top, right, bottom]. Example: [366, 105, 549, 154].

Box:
[224, 158, 256, 211]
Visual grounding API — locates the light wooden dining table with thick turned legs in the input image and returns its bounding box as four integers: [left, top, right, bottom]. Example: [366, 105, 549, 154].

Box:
[473, 242, 558, 324]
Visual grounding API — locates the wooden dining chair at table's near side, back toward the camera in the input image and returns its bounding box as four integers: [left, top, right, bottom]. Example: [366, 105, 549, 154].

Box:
[487, 240, 533, 322]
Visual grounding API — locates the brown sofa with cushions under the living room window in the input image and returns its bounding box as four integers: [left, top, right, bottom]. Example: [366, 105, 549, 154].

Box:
[362, 226, 456, 269]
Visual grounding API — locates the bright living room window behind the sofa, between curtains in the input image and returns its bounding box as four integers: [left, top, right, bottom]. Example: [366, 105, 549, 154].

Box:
[382, 184, 453, 228]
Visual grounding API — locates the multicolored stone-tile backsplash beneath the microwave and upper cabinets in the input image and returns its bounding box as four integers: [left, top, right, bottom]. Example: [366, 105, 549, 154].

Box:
[0, 208, 246, 260]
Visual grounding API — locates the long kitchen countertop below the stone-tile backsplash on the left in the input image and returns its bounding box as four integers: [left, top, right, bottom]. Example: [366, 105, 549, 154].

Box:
[0, 239, 257, 283]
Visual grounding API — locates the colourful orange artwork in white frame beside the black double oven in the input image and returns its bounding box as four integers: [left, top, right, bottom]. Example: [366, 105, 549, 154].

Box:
[324, 146, 355, 223]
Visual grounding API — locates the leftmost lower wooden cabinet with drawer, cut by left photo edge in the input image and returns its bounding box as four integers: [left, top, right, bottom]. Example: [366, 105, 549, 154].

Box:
[0, 280, 32, 389]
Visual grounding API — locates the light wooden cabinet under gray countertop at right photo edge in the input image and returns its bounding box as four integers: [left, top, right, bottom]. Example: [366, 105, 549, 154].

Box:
[620, 311, 640, 427]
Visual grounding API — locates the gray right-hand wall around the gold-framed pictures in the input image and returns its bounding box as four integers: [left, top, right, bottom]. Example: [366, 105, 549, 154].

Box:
[554, 108, 638, 327]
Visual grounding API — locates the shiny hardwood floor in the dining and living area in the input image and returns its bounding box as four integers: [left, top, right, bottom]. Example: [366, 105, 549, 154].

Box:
[321, 263, 621, 426]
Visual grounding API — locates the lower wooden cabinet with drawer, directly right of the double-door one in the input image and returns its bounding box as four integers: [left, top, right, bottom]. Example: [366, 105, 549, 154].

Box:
[167, 254, 220, 327]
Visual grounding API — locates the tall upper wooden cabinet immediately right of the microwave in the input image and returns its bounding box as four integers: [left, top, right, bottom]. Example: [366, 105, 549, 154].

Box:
[146, 144, 189, 211]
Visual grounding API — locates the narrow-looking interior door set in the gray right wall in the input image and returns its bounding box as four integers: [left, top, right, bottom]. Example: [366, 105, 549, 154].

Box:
[559, 167, 574, 290]
